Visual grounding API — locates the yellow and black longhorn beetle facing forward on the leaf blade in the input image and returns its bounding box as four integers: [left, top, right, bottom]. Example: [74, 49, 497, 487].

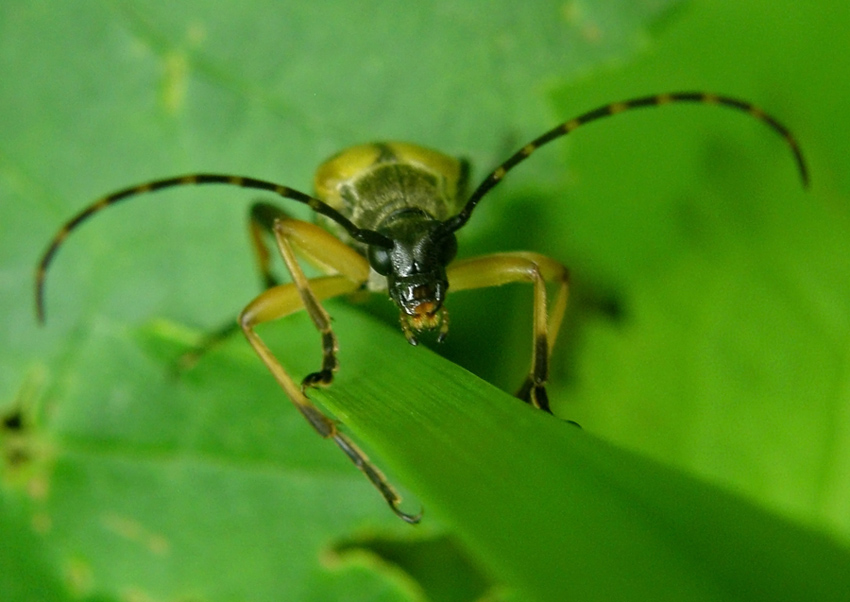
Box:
[35, 92, 808, 523]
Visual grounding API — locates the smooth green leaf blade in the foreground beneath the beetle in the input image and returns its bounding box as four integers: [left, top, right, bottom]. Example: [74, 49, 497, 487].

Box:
[308, 307, 850, 601]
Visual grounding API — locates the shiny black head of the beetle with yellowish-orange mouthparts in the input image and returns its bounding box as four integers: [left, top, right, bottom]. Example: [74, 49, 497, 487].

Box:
[369, 209, 457, 345]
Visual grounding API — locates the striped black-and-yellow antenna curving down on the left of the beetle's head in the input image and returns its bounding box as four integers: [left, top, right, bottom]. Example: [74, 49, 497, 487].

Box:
[35, 173, 393, 323]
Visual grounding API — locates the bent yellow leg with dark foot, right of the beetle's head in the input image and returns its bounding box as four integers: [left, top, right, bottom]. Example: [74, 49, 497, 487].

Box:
[447, 252, 569, 413]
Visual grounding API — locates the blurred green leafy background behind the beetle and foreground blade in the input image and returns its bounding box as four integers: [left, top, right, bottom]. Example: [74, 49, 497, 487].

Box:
[0, 0, 850, 600]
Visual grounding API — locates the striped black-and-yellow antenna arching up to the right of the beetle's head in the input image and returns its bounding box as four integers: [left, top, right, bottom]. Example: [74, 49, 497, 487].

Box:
[444, 92, 809, 234]
